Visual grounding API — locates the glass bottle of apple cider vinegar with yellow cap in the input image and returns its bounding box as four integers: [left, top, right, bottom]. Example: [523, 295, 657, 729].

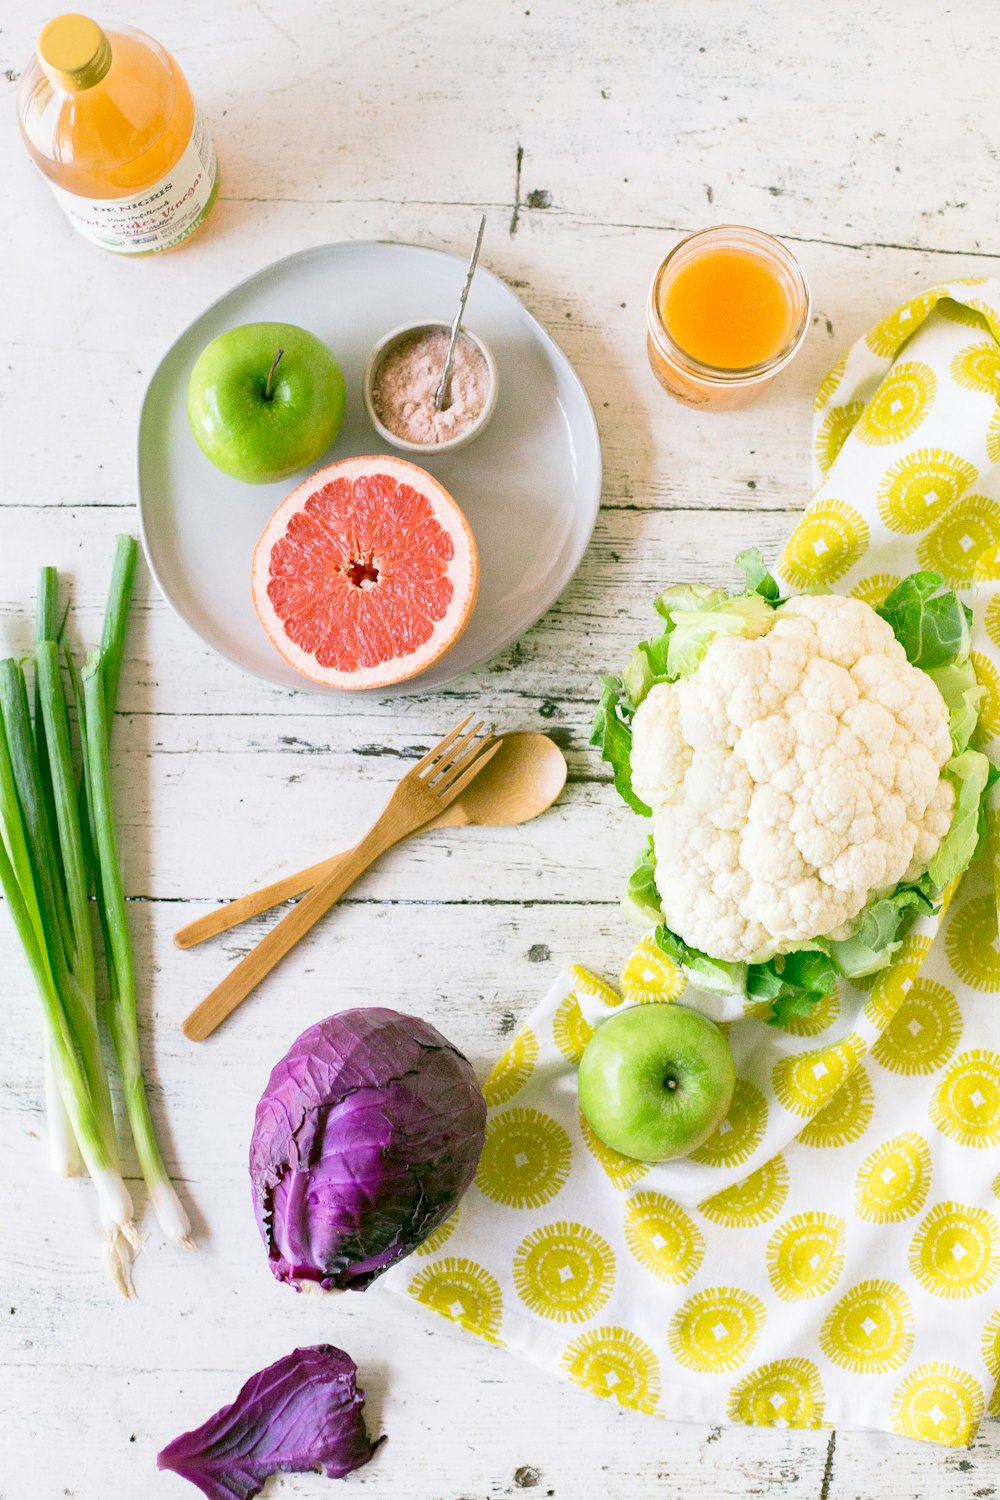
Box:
[18, 15, 219, 255]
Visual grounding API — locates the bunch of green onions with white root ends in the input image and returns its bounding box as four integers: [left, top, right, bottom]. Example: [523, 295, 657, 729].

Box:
[0, 537, 190, 1295]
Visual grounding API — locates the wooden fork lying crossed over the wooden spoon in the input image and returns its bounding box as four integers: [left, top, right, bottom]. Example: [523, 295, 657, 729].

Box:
[183, 714, 502, 1041]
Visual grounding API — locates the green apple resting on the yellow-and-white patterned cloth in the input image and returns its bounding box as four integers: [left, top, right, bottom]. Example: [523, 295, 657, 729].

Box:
[577, 1005, 736, 1161]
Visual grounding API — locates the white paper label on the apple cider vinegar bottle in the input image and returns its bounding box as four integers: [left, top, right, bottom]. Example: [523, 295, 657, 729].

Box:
[49, 111, 219, 255]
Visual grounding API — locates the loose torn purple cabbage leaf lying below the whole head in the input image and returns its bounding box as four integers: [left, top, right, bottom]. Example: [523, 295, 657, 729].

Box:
[156, 1344, 384, 1500]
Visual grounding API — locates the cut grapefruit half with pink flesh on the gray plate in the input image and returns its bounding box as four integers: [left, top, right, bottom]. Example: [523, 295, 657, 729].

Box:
[252, 458, 480, 689]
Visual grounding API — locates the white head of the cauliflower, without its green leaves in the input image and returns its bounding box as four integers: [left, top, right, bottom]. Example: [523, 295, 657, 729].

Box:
[631, 594, 955, 963]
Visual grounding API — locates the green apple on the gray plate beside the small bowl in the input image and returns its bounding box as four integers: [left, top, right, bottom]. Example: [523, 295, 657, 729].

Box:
[187, 323, 345, 485]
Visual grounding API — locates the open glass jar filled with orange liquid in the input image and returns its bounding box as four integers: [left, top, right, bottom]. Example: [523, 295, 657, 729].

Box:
[646, 224, 813, 411]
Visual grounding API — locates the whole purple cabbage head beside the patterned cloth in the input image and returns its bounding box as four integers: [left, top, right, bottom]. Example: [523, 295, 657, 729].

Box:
[250, 1007, 486, 1292]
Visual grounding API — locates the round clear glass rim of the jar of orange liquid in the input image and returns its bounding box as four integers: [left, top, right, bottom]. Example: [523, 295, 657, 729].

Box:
[646, 224, 813, 387]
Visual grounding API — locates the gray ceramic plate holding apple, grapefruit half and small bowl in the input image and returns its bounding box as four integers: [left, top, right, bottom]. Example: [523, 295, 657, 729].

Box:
[139, 242, 601, 696]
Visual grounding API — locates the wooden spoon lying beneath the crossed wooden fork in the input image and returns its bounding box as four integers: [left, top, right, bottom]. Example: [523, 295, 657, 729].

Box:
[174, 734, 567, 948]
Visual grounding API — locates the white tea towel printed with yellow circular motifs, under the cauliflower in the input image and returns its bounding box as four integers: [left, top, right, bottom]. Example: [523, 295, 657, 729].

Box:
[390, 281, 1000, 1445]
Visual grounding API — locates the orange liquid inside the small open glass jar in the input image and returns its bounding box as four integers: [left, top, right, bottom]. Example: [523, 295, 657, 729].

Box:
[660, 248, 795, 371]
